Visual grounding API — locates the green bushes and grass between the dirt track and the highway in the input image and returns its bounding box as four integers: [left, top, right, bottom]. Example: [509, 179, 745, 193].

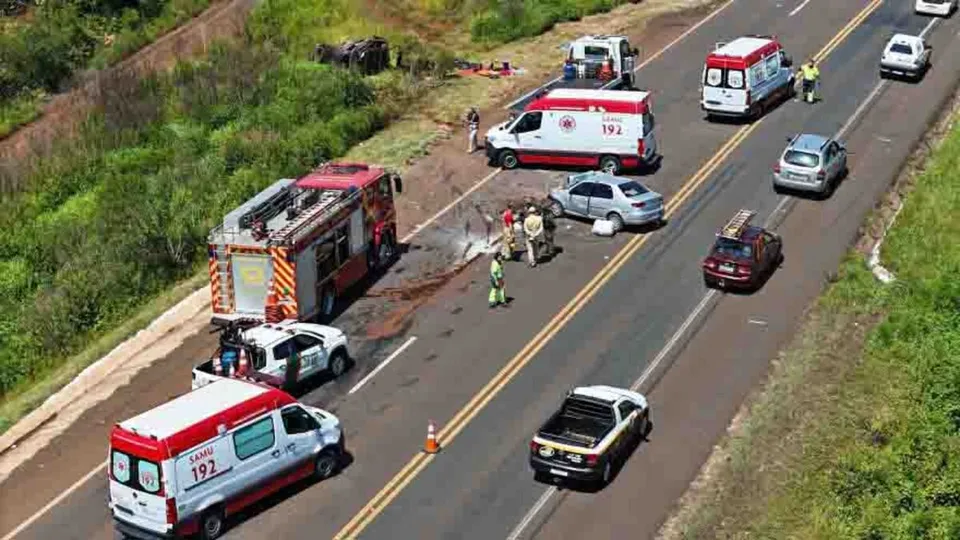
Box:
[0, 0, 688, 432]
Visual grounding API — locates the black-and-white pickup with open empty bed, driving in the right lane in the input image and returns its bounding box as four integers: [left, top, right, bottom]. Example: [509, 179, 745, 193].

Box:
[530, 386, 650, 484]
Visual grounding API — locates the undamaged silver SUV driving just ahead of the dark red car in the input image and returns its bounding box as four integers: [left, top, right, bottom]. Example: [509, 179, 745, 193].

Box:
[773, 133, 847, 195]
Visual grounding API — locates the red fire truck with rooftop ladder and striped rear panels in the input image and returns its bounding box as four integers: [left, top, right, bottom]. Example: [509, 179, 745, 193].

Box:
[209, 163, 402, 325]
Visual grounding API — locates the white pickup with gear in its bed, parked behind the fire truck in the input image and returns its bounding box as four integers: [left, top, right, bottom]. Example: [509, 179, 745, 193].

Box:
[192, 320, 350, 390]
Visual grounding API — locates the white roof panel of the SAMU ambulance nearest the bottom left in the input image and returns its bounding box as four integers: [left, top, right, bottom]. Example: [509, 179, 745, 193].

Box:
[120, 379, 270, 439]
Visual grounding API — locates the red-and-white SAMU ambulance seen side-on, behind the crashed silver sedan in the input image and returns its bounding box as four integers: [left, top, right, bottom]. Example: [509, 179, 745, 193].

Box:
[486, 88, 657, 174]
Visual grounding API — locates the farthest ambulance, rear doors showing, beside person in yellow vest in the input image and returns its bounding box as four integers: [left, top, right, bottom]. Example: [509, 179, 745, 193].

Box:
[700, 37, 795, 118]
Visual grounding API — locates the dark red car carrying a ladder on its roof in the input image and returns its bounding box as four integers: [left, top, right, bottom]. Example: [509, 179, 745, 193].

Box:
[703, 210, 783, 289]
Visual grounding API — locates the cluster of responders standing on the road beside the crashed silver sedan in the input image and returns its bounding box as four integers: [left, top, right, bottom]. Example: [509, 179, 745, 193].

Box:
[489, 204, 557, 308]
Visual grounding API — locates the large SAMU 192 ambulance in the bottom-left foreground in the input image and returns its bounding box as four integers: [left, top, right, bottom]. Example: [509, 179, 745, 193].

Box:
[108, 379, 344, 539]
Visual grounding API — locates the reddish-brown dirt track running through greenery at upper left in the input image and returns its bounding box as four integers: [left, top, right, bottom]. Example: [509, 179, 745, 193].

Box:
[0, 0, 256, 177]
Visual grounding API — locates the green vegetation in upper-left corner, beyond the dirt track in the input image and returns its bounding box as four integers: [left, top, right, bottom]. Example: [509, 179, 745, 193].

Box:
[0, 0, 210, 138]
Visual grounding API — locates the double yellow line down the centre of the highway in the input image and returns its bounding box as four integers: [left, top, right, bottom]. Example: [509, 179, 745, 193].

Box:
[334, 0, 883, 540]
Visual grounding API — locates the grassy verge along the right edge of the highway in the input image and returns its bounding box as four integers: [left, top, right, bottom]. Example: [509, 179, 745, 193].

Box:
[664, 107, 960, 540]
